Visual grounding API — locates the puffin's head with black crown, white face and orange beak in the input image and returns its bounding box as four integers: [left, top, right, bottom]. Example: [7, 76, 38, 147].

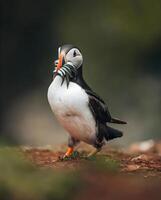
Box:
[55, 44, 83, 71]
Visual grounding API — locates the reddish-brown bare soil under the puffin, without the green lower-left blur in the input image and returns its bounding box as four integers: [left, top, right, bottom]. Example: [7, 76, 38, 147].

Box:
[23, 141, 161, 200]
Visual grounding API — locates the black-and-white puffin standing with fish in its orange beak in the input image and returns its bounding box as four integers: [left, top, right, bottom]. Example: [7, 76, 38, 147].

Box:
[47, 44, 126, 158]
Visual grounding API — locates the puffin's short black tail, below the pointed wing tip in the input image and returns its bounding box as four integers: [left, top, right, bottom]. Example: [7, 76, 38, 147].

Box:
[104, 126, 123, 141]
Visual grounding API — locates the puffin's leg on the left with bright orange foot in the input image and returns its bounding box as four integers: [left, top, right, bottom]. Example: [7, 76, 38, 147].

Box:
[63, 136, 79, 158]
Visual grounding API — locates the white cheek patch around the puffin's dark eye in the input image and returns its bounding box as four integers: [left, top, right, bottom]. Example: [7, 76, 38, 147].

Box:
[64, 48, 83, 68]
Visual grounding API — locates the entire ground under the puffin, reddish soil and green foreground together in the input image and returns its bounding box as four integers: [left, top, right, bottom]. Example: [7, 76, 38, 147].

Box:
[0, 140, 161, 200]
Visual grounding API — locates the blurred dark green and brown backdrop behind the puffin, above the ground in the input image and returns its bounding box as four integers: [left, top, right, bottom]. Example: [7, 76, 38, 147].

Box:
[0, 0, 161, 146]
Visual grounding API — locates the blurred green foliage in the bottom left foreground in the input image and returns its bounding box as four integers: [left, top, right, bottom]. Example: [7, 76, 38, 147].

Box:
[0, 147, 81, 200]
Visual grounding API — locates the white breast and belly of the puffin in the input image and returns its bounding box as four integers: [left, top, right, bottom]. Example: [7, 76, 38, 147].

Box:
[48, 76, 96, 144]
